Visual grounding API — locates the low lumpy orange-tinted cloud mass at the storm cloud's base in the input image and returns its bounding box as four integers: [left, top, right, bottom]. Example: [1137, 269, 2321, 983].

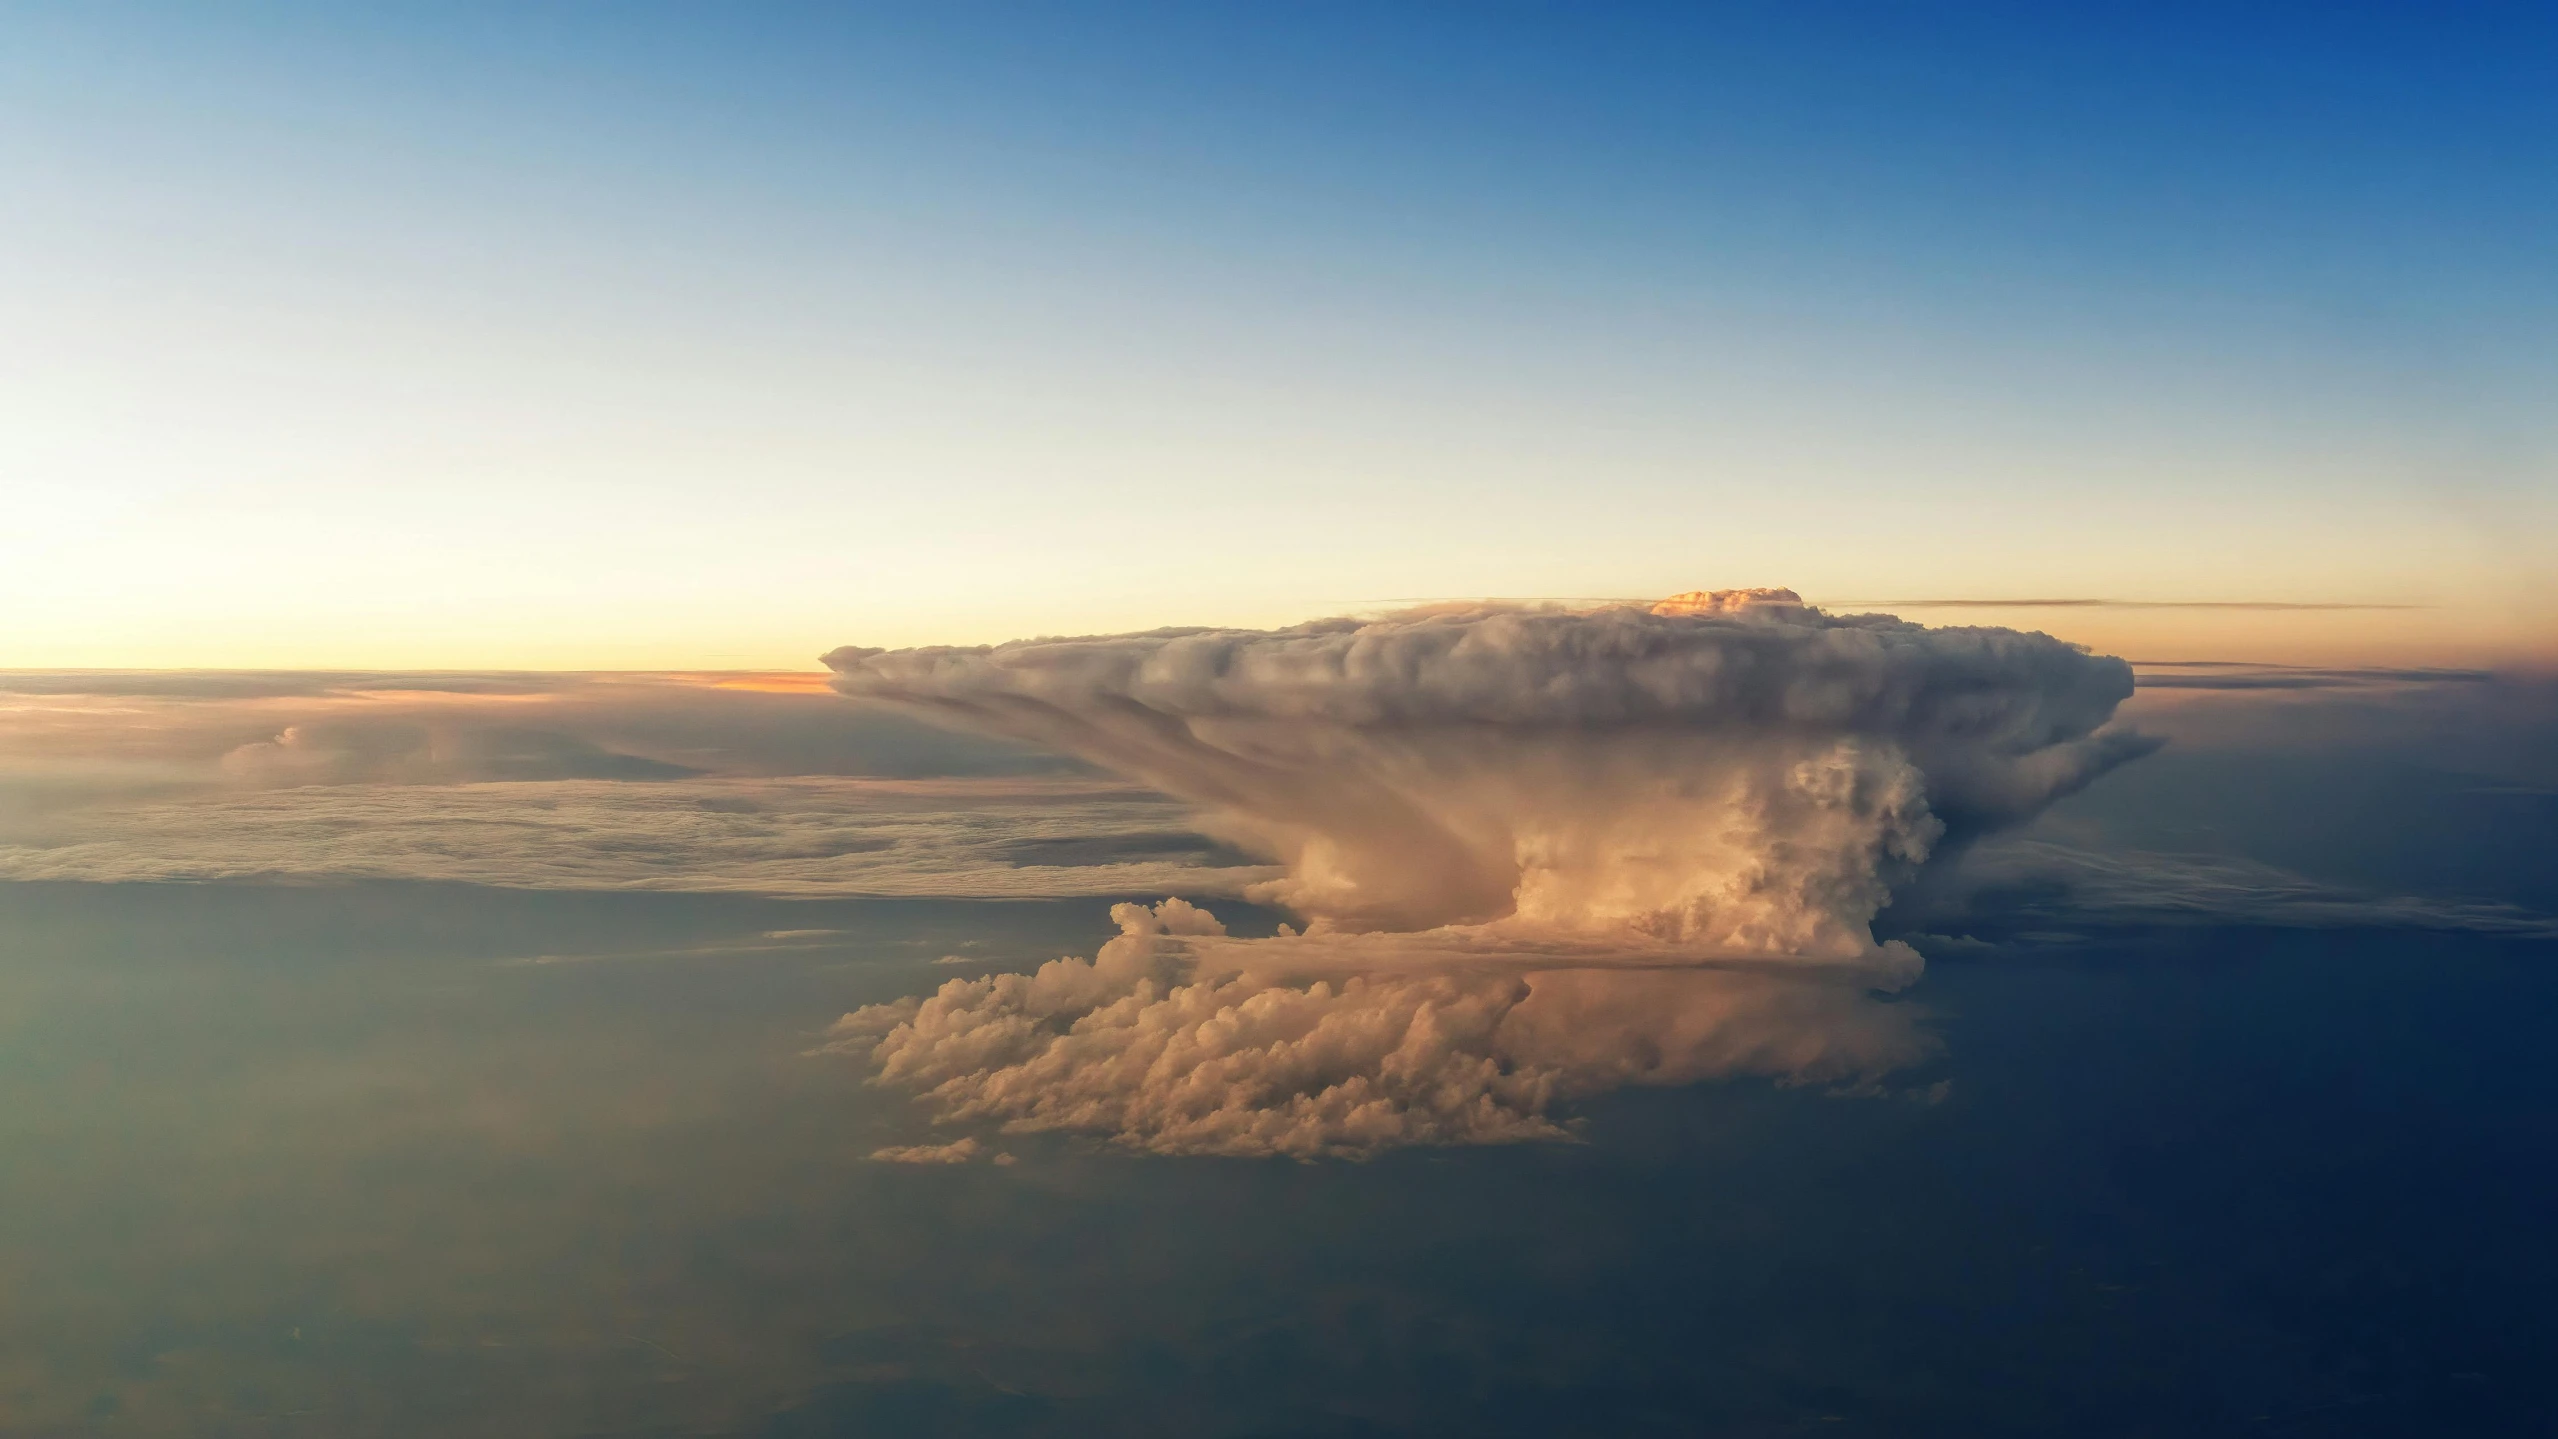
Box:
[826, 900, 1929, 1158]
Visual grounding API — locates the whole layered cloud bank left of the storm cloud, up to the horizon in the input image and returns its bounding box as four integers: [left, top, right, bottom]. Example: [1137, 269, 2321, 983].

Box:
[0, 672, 1176, 895]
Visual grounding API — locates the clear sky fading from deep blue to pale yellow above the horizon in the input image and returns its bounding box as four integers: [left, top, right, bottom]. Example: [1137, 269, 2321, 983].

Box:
[0, 5, 2558, 667]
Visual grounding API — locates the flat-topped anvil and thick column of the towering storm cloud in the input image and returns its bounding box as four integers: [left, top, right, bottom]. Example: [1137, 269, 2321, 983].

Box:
[826, 590, 2144, 953]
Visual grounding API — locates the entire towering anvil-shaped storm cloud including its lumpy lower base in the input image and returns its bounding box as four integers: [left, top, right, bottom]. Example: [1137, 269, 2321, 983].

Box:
[826, 590, 2146, 1155]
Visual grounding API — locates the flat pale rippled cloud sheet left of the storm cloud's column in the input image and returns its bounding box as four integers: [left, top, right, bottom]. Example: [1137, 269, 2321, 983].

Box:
[0, 777, 1274, 897]
